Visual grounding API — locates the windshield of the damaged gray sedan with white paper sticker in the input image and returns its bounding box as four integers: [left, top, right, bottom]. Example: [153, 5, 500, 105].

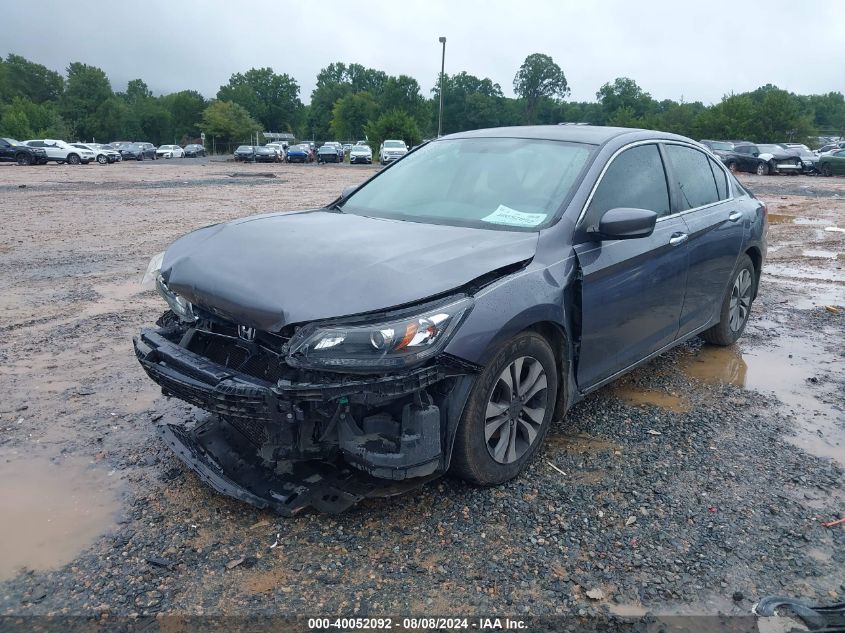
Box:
[342, 138, 594, 231]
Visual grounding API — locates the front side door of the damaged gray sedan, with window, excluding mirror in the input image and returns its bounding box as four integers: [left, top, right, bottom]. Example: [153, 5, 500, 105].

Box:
[575, 143, 688, 390]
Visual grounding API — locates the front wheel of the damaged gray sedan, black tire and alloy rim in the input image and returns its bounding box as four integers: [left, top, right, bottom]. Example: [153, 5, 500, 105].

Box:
[451, 331, 558, 486]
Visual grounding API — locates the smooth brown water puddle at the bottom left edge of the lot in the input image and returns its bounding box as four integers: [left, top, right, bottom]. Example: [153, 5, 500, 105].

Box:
[0, 454, 119, 580]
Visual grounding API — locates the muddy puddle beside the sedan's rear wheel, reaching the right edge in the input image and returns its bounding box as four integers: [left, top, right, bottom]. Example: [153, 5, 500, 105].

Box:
[681, 332, 845, 466]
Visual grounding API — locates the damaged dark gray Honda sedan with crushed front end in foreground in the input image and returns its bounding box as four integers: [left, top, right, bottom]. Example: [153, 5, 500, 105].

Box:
[134, 126, 767, 515]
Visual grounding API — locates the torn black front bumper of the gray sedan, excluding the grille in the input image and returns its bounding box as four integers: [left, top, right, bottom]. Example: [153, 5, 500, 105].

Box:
[134, 328, 473, 513]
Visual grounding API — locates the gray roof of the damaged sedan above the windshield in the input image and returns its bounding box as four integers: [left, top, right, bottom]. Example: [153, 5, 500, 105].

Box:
[442, 125, 690, 145]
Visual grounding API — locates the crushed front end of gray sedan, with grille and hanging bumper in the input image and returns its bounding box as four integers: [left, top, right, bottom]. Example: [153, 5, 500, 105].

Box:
[134, 310, 477, 515]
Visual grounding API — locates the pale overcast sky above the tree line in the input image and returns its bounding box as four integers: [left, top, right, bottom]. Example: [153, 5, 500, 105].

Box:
[0, 0, 845, 104]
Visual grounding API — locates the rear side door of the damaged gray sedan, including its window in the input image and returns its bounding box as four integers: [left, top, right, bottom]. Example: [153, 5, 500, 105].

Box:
[664, 143, 745, 337]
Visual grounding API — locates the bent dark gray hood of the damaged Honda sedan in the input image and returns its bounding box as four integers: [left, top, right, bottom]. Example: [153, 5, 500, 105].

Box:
[161, 210, 538, 332]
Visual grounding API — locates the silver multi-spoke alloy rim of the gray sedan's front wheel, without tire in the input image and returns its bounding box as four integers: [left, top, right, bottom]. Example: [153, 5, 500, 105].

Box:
[484, 356, 549, 464]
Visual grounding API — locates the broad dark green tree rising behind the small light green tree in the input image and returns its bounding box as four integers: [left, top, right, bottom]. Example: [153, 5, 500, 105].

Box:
[217, 68, 302, 132]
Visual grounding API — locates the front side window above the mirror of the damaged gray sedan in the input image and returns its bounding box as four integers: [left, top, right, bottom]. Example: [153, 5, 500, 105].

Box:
[588, 144, 669, 218]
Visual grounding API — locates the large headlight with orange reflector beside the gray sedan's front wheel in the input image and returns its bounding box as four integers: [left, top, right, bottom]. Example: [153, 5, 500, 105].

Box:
[287, 297, 472, 371]
